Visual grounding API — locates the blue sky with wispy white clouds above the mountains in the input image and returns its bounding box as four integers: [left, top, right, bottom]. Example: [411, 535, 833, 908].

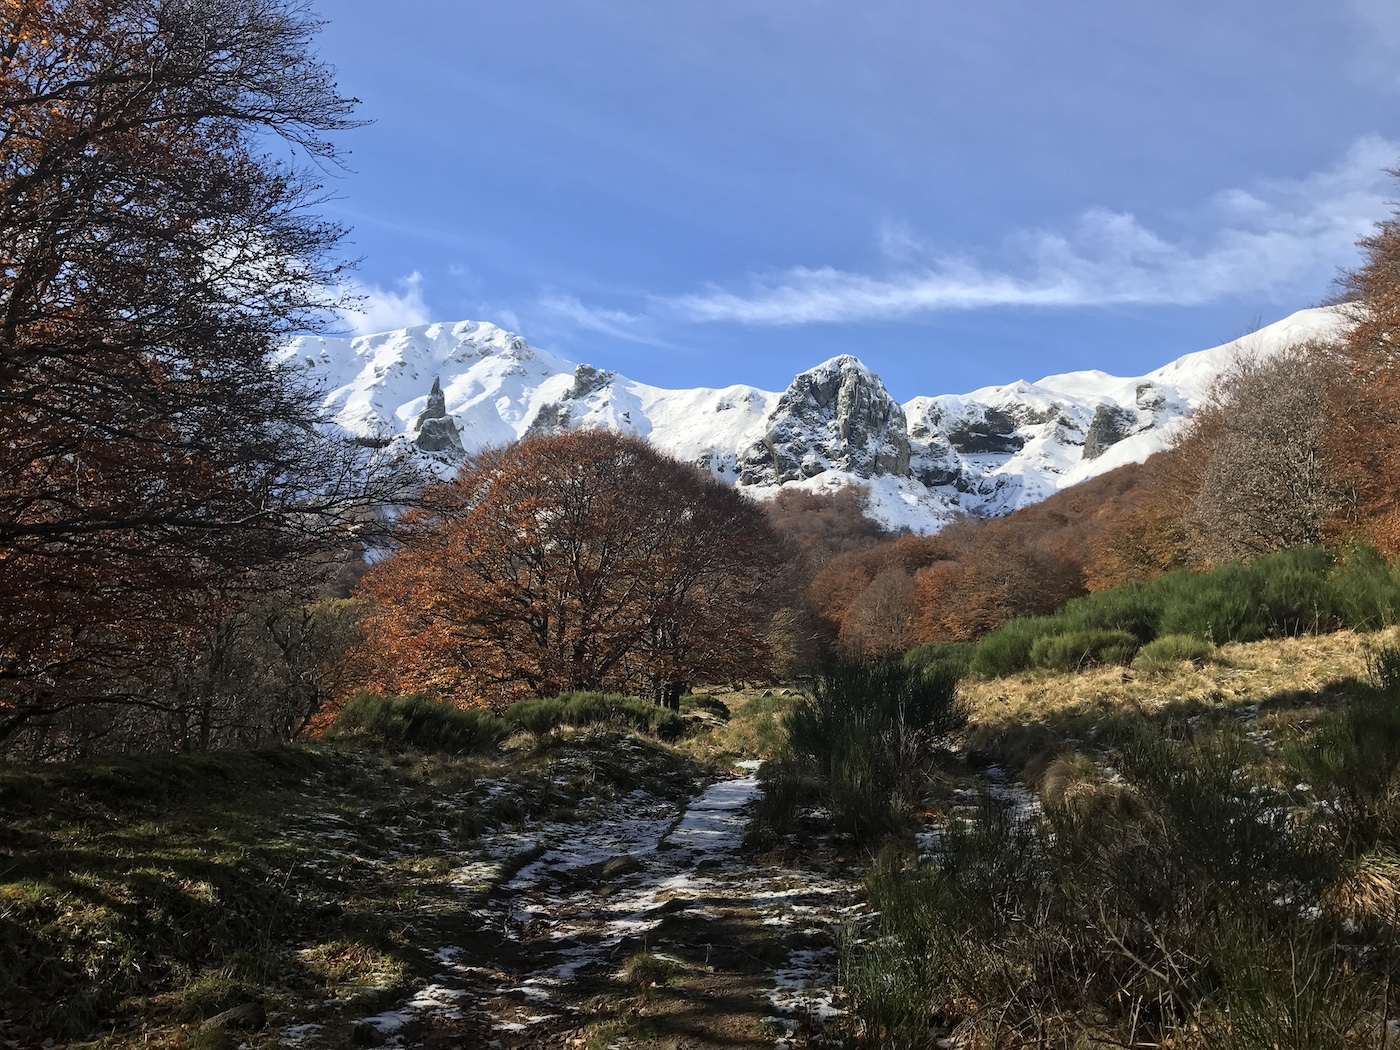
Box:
[318, 0, 1400, 399]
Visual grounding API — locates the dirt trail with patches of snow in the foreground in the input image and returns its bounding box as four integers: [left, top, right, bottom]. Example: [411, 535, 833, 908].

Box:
[301, 764, 860, 1050]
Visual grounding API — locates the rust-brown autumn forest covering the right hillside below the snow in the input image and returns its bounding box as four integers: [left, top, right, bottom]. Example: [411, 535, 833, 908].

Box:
[806, 233, 1400, 658]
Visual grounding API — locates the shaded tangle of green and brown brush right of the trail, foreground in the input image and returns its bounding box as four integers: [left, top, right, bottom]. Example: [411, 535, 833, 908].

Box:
[843, 725, 1355, 1050]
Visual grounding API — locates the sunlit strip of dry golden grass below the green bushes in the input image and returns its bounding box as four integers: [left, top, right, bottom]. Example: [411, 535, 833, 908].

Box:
[960, 629, 1400, 767]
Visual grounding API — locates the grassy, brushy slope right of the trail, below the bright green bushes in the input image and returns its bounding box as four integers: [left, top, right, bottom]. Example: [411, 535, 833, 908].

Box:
[760, 630, 1400, 1050]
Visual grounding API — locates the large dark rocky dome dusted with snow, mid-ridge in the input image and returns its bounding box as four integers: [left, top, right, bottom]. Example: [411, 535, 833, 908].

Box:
[739, 356, 910, 484]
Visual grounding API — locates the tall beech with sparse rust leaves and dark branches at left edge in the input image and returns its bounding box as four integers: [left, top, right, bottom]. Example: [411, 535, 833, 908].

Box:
[0, 0, 414, 746]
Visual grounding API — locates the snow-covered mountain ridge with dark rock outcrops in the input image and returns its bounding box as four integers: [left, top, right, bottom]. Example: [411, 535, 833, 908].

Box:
[281, 308, 1345, 532]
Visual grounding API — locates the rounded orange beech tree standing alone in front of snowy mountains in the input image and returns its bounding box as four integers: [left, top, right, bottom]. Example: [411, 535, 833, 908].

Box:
[356, 430, 778, 707]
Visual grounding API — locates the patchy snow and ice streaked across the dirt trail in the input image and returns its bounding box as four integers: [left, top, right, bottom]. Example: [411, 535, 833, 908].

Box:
[340, 762, 858, 1046]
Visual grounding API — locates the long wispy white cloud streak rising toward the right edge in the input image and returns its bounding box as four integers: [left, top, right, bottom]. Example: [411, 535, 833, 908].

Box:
[664, 136, 1400, 325]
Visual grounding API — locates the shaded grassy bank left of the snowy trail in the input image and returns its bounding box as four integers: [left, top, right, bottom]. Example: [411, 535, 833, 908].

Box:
[0, 722, 703, 1050]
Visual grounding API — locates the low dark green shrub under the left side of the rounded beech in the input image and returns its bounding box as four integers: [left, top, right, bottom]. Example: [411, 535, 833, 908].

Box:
[328, 693, 507, 755]
